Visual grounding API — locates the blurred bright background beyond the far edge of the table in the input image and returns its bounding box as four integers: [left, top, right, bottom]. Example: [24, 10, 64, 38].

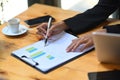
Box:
[0, 0, 119, 21]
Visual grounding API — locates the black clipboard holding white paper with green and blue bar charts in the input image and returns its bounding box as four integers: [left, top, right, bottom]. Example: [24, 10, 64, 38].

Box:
[12, 32, 93, 73]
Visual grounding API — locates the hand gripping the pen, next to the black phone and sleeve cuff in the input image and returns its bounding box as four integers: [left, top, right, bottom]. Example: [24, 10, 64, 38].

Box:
[37, 22, 68, 37]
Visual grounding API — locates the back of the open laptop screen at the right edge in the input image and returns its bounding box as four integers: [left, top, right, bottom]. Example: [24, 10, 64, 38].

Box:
[93, 32, 120, 64]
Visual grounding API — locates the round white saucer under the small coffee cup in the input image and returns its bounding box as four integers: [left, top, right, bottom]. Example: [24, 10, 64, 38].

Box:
[2, 24, 28, 36]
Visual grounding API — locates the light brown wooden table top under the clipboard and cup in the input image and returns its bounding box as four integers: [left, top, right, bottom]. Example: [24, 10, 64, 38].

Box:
[0, 4, 120, 80]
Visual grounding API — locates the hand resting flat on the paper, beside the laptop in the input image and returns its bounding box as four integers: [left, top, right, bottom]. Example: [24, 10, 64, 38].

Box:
[66, 34, 93, 52]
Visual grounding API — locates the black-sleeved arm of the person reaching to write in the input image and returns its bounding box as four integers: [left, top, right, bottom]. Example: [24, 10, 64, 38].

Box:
[64, 0, 119, 34]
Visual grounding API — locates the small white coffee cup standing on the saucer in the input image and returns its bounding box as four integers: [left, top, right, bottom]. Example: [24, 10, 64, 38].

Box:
[8, 18, 20, 33]
